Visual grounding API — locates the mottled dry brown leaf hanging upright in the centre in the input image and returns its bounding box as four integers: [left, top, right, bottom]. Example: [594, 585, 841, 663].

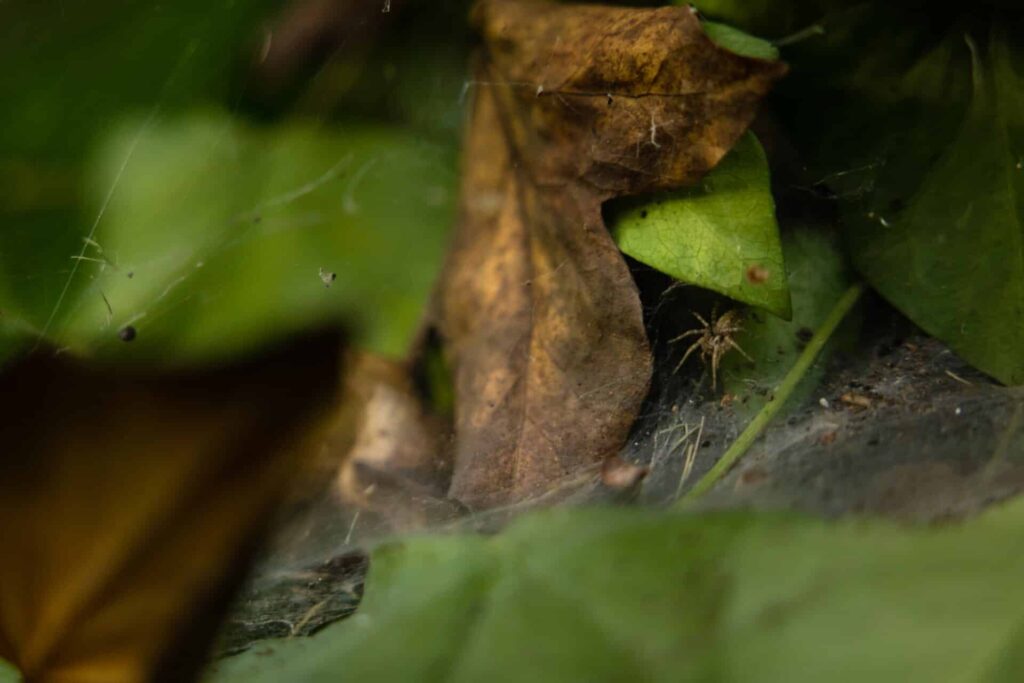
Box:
[435, 0, 785, 508]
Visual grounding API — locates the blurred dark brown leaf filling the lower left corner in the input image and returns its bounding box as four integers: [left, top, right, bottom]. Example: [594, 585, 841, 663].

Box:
[0, 334, 340, 682]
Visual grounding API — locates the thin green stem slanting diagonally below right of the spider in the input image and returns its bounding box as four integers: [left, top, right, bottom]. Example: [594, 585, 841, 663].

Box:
[676, 283, 864, 508]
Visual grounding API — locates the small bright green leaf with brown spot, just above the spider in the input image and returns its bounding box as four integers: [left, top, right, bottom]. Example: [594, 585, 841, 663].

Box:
[610, 133, 792, 318]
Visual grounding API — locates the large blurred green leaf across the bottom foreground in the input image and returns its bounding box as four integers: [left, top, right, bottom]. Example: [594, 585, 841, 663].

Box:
[210, 501, 1024, 683]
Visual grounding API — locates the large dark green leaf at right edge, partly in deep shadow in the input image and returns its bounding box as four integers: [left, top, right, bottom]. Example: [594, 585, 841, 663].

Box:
[779, 5, 1024, 384]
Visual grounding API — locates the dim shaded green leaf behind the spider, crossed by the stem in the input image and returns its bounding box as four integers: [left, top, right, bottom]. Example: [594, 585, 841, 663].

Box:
[719, 225, 850, 418]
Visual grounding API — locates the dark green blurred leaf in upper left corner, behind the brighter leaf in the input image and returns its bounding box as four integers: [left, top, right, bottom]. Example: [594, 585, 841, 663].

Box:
[0, 0, 281, 362]
